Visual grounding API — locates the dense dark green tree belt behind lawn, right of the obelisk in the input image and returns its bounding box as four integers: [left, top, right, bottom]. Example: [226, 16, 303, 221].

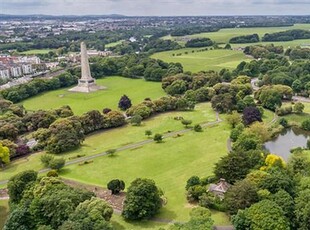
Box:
[91, 54, 183, 81]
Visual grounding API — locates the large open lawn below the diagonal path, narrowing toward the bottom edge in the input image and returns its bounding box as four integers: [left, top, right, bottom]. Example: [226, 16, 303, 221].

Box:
[61, 122, 230, 224]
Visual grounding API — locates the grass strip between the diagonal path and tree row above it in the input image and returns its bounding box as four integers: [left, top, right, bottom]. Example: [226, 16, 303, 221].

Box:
[0, 103, 216, 180]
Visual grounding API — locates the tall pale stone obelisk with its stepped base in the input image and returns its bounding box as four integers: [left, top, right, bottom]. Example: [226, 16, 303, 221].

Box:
[69, 42, 105, 93]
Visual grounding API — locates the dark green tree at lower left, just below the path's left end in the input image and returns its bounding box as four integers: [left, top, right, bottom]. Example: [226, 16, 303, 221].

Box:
[8, 170, 38, 203]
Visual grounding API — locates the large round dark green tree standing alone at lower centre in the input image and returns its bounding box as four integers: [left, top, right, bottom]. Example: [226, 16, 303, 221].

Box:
[122, 178, 162, 220]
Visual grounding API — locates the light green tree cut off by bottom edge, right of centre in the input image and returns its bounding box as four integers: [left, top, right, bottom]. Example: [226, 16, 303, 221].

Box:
[169, 207, 214, 230]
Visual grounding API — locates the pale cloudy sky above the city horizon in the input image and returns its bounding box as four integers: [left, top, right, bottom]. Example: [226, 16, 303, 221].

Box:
[0, 0, 310, 16]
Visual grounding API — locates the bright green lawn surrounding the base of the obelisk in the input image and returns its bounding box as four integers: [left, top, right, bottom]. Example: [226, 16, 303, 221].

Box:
[21, 77, 165, 115]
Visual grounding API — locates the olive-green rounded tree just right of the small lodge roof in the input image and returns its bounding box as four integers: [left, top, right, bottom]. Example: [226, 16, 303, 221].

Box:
[224, 179, 259, 215]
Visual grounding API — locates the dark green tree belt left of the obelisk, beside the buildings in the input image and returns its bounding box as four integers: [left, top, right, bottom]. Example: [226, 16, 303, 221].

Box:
[0, 72, 78, 103]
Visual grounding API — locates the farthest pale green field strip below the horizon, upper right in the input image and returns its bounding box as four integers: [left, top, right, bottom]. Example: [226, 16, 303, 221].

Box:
[163, 24, 310, 43]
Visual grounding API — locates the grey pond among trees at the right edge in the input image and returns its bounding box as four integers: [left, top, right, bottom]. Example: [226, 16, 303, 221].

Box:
[264, 128, 310, 160]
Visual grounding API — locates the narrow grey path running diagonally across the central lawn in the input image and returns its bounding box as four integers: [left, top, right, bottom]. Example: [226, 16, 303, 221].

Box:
[0, 112, 223, 185]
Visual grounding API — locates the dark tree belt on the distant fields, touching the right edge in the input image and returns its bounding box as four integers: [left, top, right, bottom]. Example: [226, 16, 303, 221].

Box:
[262, 29, 310, 42]
